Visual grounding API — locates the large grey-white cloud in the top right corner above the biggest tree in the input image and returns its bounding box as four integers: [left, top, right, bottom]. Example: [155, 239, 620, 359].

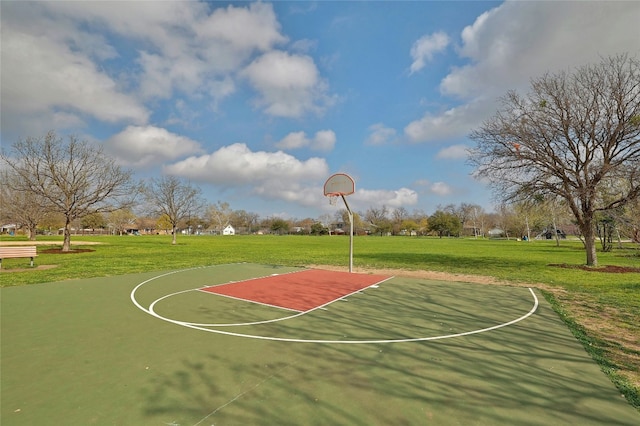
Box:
[405, 2, 640, 142]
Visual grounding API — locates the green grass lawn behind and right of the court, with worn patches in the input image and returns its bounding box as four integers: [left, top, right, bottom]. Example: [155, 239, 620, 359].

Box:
[0, 236, 640, 409]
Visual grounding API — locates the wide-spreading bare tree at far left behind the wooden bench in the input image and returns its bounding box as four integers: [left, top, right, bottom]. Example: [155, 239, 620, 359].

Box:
[2, 131, 136, 252]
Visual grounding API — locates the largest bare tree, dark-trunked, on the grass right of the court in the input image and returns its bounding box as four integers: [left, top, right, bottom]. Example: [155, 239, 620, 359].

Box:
[469, 55, 640, 266]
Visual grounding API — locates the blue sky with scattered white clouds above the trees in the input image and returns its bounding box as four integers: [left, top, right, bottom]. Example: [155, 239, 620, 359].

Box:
[0, 1, 640, 219]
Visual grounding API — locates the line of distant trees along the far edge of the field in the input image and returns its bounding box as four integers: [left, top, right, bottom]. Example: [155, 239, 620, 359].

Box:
[0, 132, 640, 251]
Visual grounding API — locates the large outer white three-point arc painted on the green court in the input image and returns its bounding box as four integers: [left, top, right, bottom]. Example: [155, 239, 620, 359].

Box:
[130, 267, 539, 344]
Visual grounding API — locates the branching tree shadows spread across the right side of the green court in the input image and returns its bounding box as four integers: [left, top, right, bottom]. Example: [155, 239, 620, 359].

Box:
[134, 268, 640, 425]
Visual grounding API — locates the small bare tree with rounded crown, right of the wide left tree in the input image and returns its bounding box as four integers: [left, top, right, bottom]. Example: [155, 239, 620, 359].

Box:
[145, 176, 204, 244]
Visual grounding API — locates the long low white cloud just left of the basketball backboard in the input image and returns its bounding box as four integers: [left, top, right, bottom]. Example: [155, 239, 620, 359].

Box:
[164, 143, 329, 202]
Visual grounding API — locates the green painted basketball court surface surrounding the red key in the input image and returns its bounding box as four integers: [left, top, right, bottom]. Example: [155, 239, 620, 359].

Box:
[0, 264, 640, 426]
